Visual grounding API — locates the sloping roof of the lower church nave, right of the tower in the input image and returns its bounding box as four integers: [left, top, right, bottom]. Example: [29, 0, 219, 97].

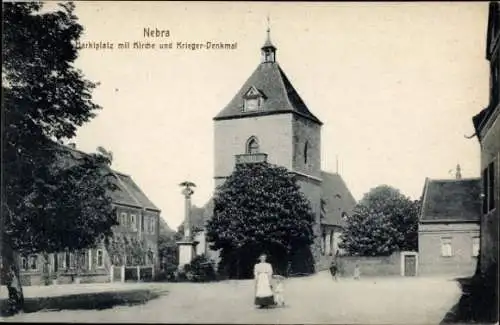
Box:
[321, 171, 356, 227]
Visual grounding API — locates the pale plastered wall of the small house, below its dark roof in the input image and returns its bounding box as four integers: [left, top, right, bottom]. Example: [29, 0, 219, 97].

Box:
[418, 223, 479, 276]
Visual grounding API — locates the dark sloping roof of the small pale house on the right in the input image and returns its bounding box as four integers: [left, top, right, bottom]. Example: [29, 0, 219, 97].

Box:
[420, 178, 482, 222]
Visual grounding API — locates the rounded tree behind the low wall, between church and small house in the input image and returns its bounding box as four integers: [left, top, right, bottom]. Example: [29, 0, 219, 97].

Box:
[339, 185, 420, 256]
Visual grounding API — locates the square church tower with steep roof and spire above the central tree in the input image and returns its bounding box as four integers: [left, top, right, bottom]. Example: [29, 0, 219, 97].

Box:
[213, 28, 322, 256]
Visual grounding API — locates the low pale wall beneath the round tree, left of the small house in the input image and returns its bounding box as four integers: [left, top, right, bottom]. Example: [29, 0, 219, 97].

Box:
[337, 252, 401, 277]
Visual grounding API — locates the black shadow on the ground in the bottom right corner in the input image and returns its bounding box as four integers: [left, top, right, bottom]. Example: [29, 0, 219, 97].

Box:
[441, 277, 498, 324]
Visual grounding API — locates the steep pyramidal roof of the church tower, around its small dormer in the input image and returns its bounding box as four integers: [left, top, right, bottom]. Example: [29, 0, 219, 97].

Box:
[214, 62, 323, 125]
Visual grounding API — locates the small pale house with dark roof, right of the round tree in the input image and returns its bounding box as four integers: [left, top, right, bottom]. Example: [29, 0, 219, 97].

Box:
[418, 178, 481, 276]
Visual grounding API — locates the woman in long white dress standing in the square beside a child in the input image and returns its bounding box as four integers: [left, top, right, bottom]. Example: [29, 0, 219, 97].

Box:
[253, 254, 274, 308]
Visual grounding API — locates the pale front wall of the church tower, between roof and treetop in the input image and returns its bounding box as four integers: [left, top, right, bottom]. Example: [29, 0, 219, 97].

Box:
[214, 114, 293, 180]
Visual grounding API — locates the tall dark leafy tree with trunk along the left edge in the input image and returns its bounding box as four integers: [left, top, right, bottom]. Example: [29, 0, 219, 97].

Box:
[0, 2, 116, 312]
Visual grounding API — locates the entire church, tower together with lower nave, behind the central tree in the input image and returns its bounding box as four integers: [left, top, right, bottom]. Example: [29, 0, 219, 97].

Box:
[193, 29, 356, 269]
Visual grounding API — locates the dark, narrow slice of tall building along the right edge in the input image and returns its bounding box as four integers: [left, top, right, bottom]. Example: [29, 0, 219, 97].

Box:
[473, 2, 500, 273]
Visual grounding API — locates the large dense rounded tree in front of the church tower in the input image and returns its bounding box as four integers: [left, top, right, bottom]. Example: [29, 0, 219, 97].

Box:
[206, 163, 314, 277]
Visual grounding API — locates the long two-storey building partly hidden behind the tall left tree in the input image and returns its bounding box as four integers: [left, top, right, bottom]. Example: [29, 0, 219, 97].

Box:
[19, 148, 160, 285]
